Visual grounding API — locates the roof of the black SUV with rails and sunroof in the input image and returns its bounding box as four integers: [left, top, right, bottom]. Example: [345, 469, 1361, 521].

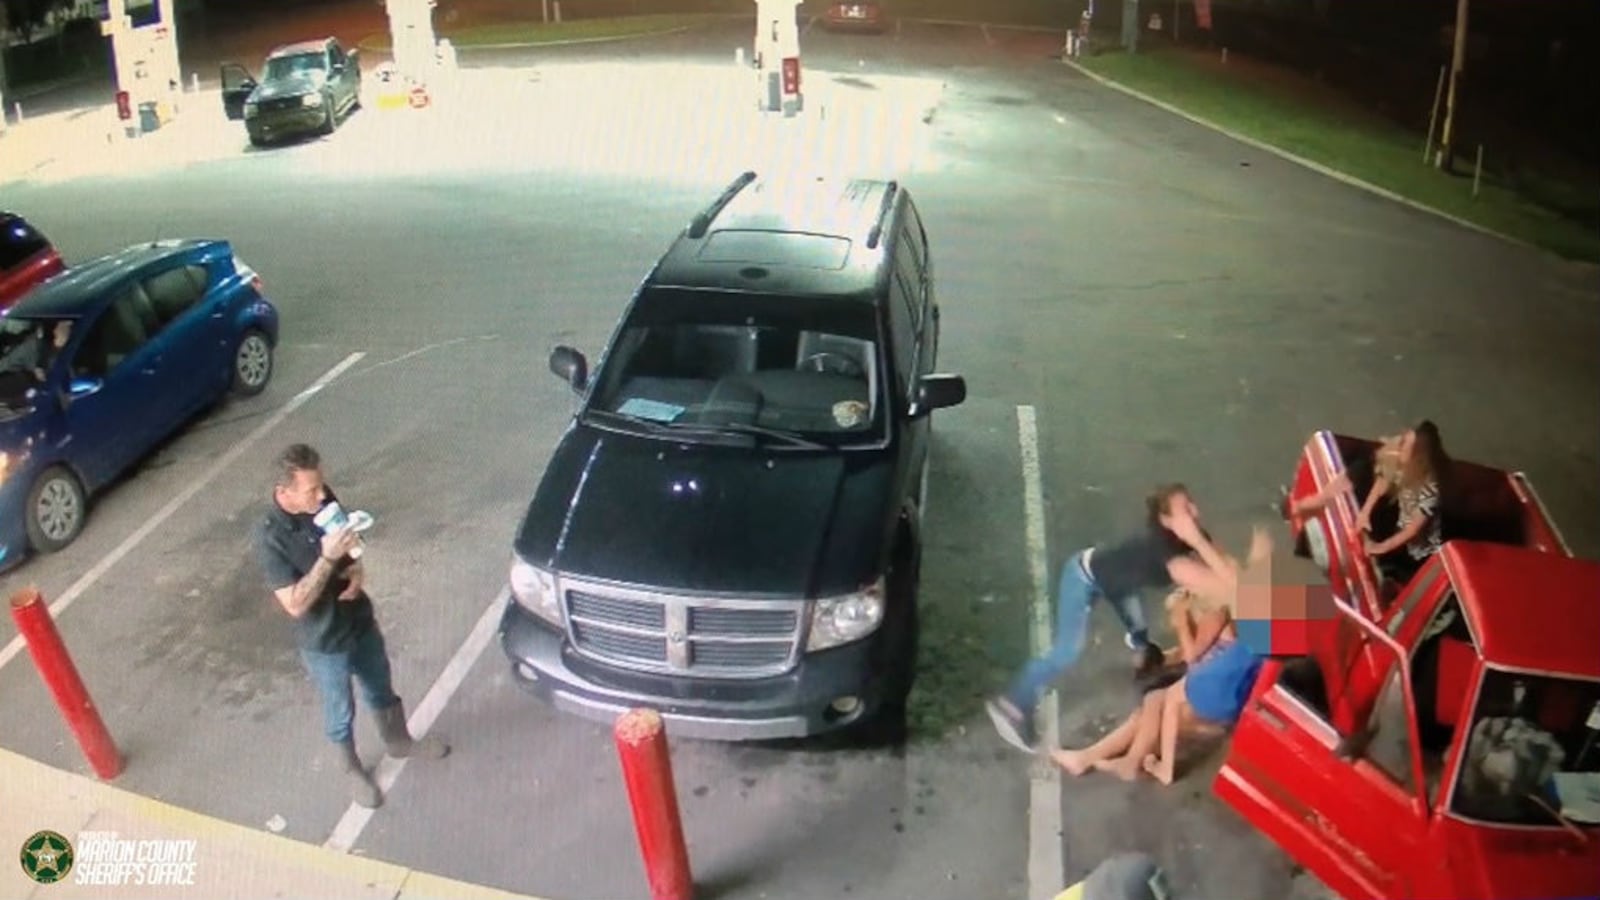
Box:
[646, 171, 906, 303]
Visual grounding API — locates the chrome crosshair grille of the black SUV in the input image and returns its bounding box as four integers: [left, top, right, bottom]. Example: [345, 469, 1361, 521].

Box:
[563, 586, 802, 677]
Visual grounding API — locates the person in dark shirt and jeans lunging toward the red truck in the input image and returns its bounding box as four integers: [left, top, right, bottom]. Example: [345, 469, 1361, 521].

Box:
[987, 484, 1235, 753]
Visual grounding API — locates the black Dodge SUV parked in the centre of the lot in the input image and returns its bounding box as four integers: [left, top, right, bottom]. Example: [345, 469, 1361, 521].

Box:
[501, 171, 966, 740]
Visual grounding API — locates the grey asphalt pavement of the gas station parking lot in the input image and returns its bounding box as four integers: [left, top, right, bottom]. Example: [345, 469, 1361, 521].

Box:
[0, 12, 1600, 900]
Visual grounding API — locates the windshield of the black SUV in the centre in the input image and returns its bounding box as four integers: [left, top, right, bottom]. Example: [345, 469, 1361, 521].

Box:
[587, 288, 883, 445]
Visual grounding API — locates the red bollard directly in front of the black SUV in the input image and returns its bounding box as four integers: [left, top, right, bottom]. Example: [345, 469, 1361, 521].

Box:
[613, 709, 694, 900]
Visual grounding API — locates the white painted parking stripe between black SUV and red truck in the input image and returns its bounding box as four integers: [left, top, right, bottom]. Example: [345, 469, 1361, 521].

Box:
[1016, 407, 1066, 900]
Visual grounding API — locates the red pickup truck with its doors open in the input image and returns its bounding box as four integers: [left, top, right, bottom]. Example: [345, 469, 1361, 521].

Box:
[1213, 432, 1600, 900]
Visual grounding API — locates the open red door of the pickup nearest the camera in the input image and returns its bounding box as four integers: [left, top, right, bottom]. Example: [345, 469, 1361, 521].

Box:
[1214, 588, 1430, 900]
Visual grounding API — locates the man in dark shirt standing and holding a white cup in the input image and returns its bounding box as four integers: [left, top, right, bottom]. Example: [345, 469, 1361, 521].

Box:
[254, 444, 450, 809]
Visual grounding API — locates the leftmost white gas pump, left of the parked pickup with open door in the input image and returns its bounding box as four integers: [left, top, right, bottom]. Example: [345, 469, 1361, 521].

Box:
[101, 0, 182, 135]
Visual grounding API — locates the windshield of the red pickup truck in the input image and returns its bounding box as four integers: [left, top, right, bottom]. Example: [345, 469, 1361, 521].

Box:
[1451, 669, 1600, 825]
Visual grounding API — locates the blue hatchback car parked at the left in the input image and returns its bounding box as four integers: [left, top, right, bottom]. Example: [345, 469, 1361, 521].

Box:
[0, 240, 278, 569]
